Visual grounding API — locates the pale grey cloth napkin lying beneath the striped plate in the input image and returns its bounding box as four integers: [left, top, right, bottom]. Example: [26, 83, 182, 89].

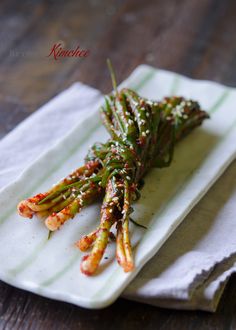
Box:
[0, 83, 236, 311]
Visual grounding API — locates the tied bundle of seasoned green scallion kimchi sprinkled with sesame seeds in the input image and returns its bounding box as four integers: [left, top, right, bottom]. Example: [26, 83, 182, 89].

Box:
[18, 60, 208, 275]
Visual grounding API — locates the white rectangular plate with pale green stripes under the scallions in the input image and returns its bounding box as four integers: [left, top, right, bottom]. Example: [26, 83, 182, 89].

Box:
[0, 65, 236, 308]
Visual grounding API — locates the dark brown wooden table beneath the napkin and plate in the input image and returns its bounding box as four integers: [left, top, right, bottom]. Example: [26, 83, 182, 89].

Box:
[0, 0, 236, 330]
